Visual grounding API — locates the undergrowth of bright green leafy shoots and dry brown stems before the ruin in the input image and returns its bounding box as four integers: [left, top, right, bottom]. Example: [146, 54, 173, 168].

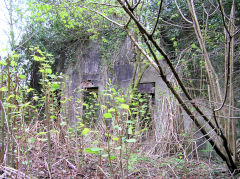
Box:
[0, 48, 232, 178]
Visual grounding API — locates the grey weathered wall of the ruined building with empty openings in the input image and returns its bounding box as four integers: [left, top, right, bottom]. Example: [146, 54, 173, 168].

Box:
[61, 35, 181, 141]
